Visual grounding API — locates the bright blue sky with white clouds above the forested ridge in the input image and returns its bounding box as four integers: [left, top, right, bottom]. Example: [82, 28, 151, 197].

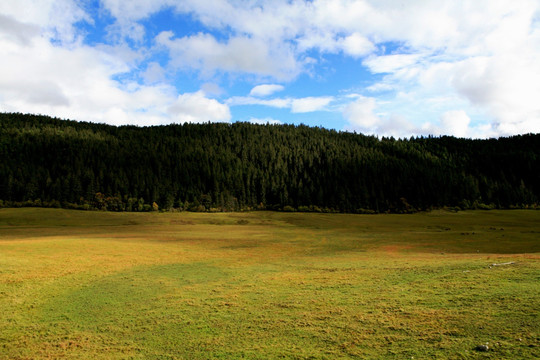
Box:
[0, 0, 540, 138]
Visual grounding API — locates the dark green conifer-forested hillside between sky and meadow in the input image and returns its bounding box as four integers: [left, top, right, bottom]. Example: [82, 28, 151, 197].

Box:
[0, 114, 540, 212]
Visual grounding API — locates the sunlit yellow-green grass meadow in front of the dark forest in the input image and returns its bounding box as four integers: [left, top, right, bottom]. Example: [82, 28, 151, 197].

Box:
[0, 208, 540, 359]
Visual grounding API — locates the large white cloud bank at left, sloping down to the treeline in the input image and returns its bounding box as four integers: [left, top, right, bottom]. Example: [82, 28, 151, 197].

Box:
[0, 2, 231, 125]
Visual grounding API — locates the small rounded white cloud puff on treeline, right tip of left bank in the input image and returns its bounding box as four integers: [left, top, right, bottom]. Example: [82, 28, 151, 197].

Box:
[168, 91, 231, 123]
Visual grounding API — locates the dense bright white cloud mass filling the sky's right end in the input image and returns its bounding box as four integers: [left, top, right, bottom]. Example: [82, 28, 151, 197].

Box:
[350, 1, 540, 137]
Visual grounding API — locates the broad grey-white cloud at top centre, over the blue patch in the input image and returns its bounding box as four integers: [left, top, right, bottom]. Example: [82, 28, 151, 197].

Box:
[103, 0, 376, 80]
